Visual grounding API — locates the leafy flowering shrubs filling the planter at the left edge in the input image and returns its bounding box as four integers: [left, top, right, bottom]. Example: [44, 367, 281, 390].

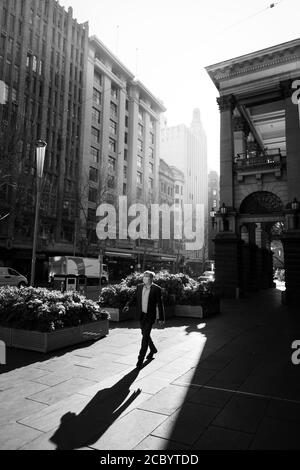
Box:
[0, 287, 108, 332]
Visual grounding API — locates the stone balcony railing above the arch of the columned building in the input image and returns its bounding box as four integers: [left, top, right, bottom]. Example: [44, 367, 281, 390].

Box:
[234, 149, 286, 169]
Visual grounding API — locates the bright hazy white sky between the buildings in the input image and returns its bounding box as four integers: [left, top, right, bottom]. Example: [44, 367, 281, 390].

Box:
[60, 0, 300, 171]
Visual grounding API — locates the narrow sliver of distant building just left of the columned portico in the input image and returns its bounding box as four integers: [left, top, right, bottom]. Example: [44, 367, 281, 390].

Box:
[208, 171, 220, 260]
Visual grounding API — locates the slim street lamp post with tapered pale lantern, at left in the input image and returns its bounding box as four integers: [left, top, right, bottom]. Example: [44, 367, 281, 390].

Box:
[30, 140, 47, 286]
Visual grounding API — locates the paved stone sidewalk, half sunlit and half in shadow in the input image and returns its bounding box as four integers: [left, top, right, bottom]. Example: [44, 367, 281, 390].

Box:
[0, 290, 300, 451]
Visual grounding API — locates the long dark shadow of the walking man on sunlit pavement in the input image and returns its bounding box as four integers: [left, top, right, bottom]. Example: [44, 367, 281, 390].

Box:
[50, 369, 141, 450]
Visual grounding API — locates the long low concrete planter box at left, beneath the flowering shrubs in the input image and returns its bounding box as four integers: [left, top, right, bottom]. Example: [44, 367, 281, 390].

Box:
[0, 320, 108, 353]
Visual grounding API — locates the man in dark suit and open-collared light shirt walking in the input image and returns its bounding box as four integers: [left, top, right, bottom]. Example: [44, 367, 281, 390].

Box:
[132, 271, 165, 368]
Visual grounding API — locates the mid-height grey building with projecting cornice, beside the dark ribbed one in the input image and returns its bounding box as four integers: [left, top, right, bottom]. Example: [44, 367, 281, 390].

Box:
[79, 36, 165, 277]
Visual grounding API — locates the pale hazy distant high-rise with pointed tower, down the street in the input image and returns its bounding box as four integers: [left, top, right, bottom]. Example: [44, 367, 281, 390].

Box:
[161, 109, 207, 271]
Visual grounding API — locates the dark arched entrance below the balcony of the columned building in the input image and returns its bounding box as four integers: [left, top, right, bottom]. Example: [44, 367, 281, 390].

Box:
[215, 191, 284, 296]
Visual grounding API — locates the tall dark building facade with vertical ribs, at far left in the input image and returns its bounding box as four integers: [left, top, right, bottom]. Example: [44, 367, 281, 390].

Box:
[0, 0, 88, 278]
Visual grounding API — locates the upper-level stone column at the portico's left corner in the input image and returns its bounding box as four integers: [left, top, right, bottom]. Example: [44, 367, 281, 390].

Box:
[217, 95, 235, 207]
